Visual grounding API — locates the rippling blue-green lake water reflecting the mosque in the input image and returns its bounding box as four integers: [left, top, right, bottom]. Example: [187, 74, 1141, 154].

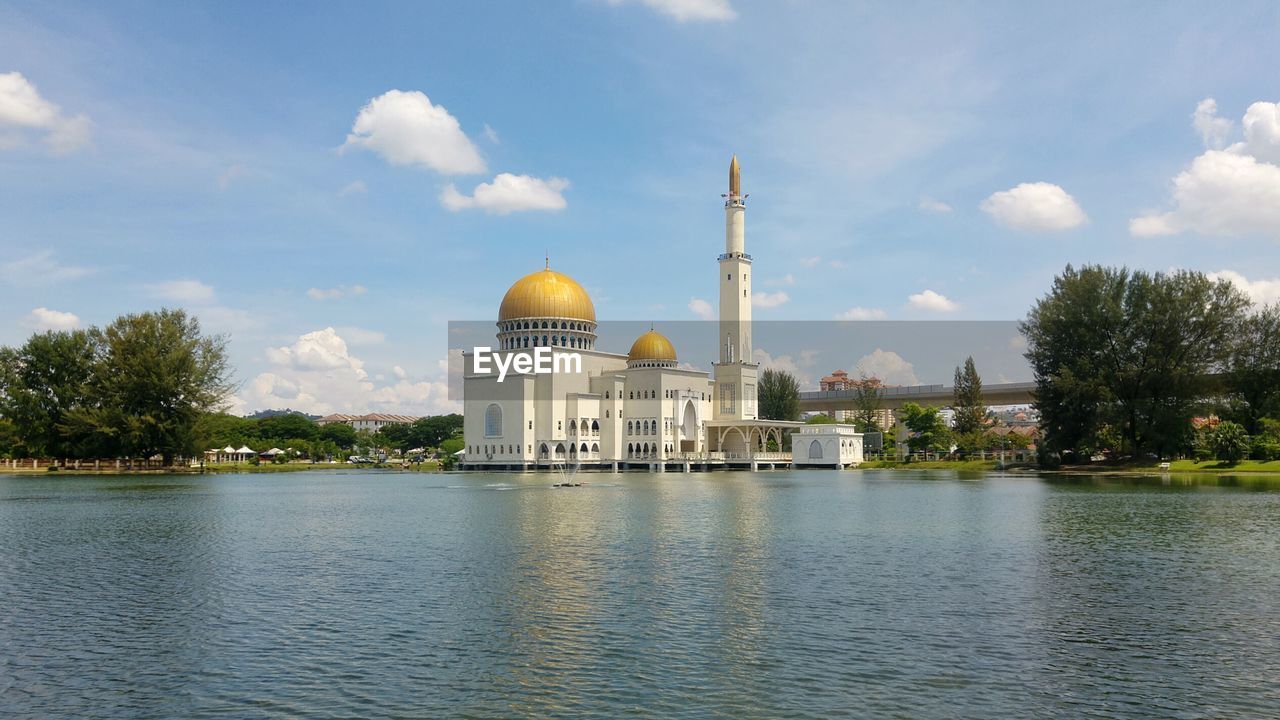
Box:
[0, 470, 1280, 719]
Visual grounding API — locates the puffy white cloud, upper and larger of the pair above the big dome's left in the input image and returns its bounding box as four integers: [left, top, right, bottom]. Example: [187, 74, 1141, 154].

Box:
[343, 90, 485, 174]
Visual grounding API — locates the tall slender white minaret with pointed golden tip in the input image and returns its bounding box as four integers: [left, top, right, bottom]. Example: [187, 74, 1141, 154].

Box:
[713, 155, 758, 420]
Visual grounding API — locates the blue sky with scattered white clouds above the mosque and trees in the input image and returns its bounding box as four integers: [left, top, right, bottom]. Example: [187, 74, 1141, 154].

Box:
[0, 0, 1280, 414]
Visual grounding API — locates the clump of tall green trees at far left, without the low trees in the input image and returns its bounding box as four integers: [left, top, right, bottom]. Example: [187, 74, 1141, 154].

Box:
[0, 310, 233, 462]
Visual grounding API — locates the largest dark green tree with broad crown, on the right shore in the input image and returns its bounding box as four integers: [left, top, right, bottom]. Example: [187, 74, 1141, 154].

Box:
[1021, 265, 1249, 459]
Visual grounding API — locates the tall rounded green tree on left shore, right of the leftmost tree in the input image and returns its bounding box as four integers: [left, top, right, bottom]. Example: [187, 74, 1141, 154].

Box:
[65, 310, 232, 462]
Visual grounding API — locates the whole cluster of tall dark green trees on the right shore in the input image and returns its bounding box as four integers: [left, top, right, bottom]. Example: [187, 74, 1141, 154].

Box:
[1021, 265, 1280, 462]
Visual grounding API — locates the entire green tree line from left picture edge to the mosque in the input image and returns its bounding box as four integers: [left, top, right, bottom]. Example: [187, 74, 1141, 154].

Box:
[0, 309, 462, 464]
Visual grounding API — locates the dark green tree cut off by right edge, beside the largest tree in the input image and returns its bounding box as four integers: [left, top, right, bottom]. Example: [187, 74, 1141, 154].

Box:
[1225, 304, 1280, 436]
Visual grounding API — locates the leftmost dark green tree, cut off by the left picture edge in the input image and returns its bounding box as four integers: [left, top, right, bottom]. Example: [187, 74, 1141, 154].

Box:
[0, 331, 97, 457]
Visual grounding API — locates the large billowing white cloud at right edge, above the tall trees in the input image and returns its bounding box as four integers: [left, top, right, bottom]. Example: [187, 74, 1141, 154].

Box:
[1129, 99, 1280, 238]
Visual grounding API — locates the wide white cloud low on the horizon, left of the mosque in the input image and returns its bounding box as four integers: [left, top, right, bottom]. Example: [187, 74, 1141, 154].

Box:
[241, 328, 460, 414]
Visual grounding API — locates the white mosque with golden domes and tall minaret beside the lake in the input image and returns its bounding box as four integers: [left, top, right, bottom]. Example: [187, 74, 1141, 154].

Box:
[462, 155, 839, 470]
